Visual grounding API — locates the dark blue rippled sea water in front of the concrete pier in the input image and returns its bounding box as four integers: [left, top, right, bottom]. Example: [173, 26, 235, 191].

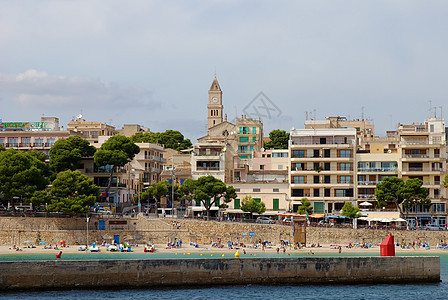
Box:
[0, 254, 448, 300]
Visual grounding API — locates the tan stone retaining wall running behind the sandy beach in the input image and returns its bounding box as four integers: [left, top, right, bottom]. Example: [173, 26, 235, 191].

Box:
[0, 217, 448, 246]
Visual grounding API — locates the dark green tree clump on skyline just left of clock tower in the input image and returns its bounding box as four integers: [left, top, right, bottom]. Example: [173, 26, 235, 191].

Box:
[131, 130, 192, 151]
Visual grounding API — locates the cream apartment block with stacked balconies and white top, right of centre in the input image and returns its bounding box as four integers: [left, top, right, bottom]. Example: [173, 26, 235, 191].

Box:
[289, 128, 357, 213]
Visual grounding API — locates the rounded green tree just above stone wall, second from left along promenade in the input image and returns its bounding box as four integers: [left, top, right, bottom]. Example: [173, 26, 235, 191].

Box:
[44, 170, 100, 215]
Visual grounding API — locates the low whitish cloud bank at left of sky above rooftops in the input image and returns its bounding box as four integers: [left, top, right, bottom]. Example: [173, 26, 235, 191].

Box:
[0, 69, 160, 110]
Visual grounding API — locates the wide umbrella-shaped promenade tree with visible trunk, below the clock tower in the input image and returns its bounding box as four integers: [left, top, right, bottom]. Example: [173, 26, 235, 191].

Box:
[181, 175, 237, 220]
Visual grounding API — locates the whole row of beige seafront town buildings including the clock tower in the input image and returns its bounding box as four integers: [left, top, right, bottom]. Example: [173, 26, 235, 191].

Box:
[0, 77, 447, 225]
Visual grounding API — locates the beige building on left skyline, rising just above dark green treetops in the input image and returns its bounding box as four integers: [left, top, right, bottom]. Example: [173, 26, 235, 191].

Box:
[67, 118, 117, 144]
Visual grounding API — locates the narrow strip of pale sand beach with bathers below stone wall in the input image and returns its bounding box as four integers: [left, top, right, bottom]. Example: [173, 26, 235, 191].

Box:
[0, 244, 448, 256]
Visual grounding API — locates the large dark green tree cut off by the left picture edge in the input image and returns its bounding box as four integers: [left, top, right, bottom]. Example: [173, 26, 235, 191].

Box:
[0, 149, 48, 209]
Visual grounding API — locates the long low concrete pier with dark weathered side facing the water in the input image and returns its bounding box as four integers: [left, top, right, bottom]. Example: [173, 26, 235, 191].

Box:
[0, 256, 440, 290]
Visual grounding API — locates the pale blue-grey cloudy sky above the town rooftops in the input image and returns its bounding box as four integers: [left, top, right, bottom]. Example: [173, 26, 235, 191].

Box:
[0, 0, 448, 141]
